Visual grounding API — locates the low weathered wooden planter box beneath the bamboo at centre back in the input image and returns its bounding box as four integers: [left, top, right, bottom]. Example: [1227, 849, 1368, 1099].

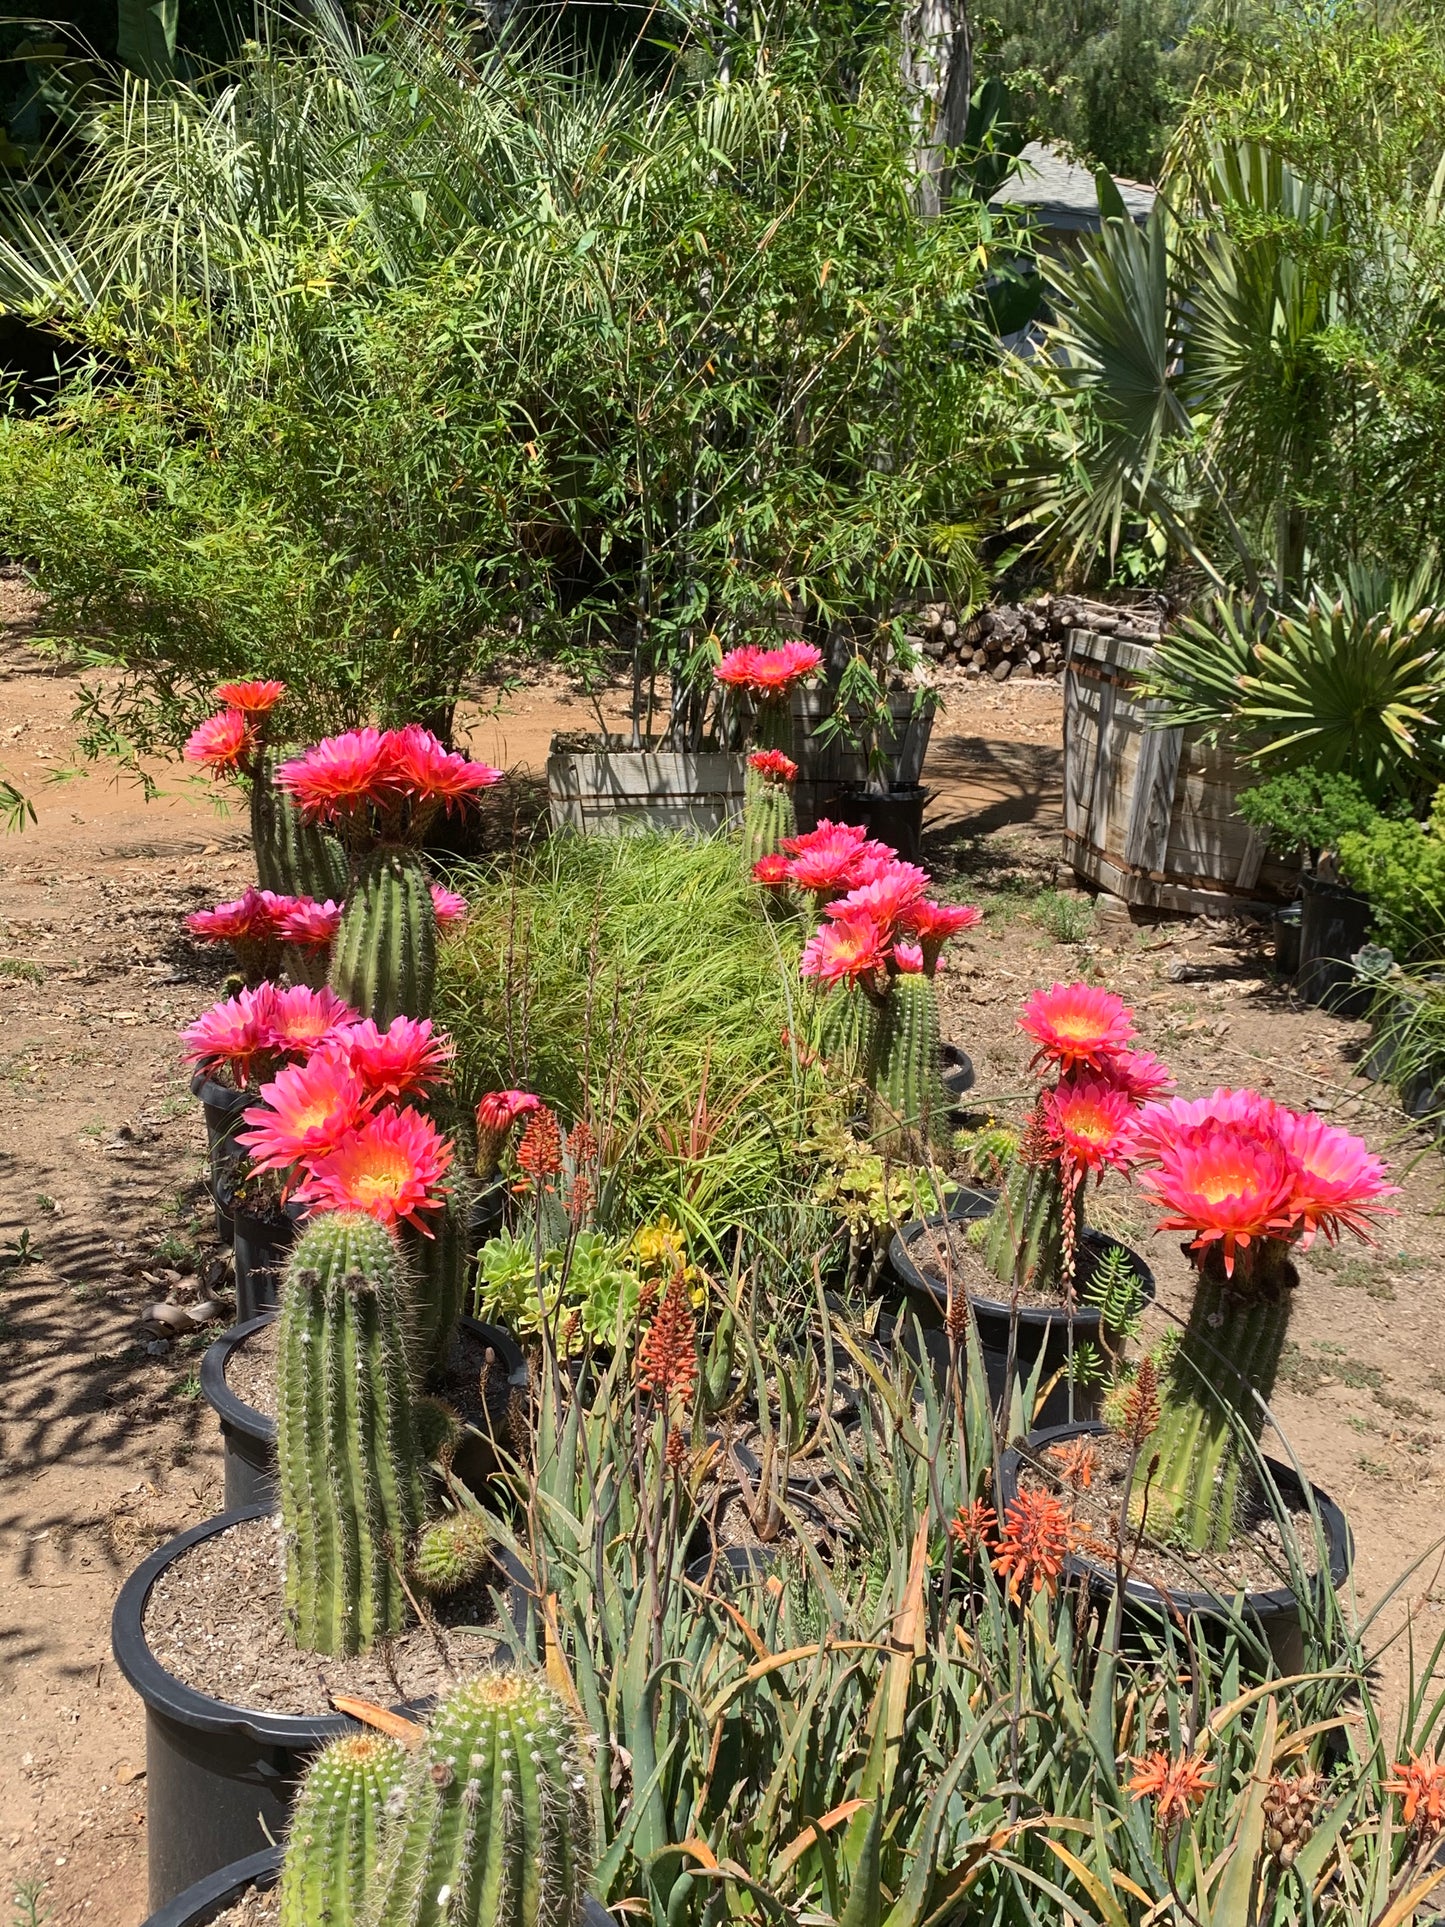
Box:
[547, 686, 933, 836]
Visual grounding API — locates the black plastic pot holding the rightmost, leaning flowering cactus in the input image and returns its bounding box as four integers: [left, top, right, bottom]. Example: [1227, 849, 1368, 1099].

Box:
[998, 1424, 1354, 1673]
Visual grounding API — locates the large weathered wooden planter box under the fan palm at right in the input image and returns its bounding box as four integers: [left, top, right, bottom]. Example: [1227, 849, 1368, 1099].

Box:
[1064, 628, 1295, 915]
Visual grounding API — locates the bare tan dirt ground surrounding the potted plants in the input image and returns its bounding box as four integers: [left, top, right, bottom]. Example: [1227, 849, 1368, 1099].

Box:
[0, 578, 1445, 1927]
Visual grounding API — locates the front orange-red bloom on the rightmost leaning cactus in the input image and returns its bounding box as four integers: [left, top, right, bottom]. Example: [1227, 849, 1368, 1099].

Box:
[1139, 1123, 1295, 1276]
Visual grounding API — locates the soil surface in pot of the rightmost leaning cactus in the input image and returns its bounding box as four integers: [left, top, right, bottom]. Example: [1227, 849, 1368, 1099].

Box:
[1019, 1432, 1318, 1599]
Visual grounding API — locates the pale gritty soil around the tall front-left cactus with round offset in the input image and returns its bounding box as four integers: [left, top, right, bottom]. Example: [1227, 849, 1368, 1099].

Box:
[145, 1518, 505, 1715]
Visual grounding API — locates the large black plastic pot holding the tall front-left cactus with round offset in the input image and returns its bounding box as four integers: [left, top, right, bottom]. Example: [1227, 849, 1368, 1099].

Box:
[110, 1505, 534, 1908]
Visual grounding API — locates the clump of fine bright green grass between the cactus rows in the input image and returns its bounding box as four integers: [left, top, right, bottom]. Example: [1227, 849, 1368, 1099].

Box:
[437, 834, 821, 1266]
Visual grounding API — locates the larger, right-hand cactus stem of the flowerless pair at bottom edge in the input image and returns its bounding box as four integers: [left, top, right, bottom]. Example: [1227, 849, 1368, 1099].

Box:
[379, 1673, 593, 1927]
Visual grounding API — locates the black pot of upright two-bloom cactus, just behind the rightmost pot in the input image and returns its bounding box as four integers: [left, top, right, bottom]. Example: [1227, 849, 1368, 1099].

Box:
[888, 1191, 1154, 1424]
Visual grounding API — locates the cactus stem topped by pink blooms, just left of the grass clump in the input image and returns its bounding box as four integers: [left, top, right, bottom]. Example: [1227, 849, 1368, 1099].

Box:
[329, 844, 437, 1029]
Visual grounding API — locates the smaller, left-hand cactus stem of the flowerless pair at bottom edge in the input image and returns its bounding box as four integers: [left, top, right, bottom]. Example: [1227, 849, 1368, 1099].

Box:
[279, 1732, 407, 1927]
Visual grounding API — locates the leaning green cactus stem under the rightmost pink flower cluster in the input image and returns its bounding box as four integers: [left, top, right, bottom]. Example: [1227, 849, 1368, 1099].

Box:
[1141, 1239, 1297, 1551]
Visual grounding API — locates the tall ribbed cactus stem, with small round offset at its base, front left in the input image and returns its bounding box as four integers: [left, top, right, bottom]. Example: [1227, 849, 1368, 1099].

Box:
[276, 1210, 424, 1653]
